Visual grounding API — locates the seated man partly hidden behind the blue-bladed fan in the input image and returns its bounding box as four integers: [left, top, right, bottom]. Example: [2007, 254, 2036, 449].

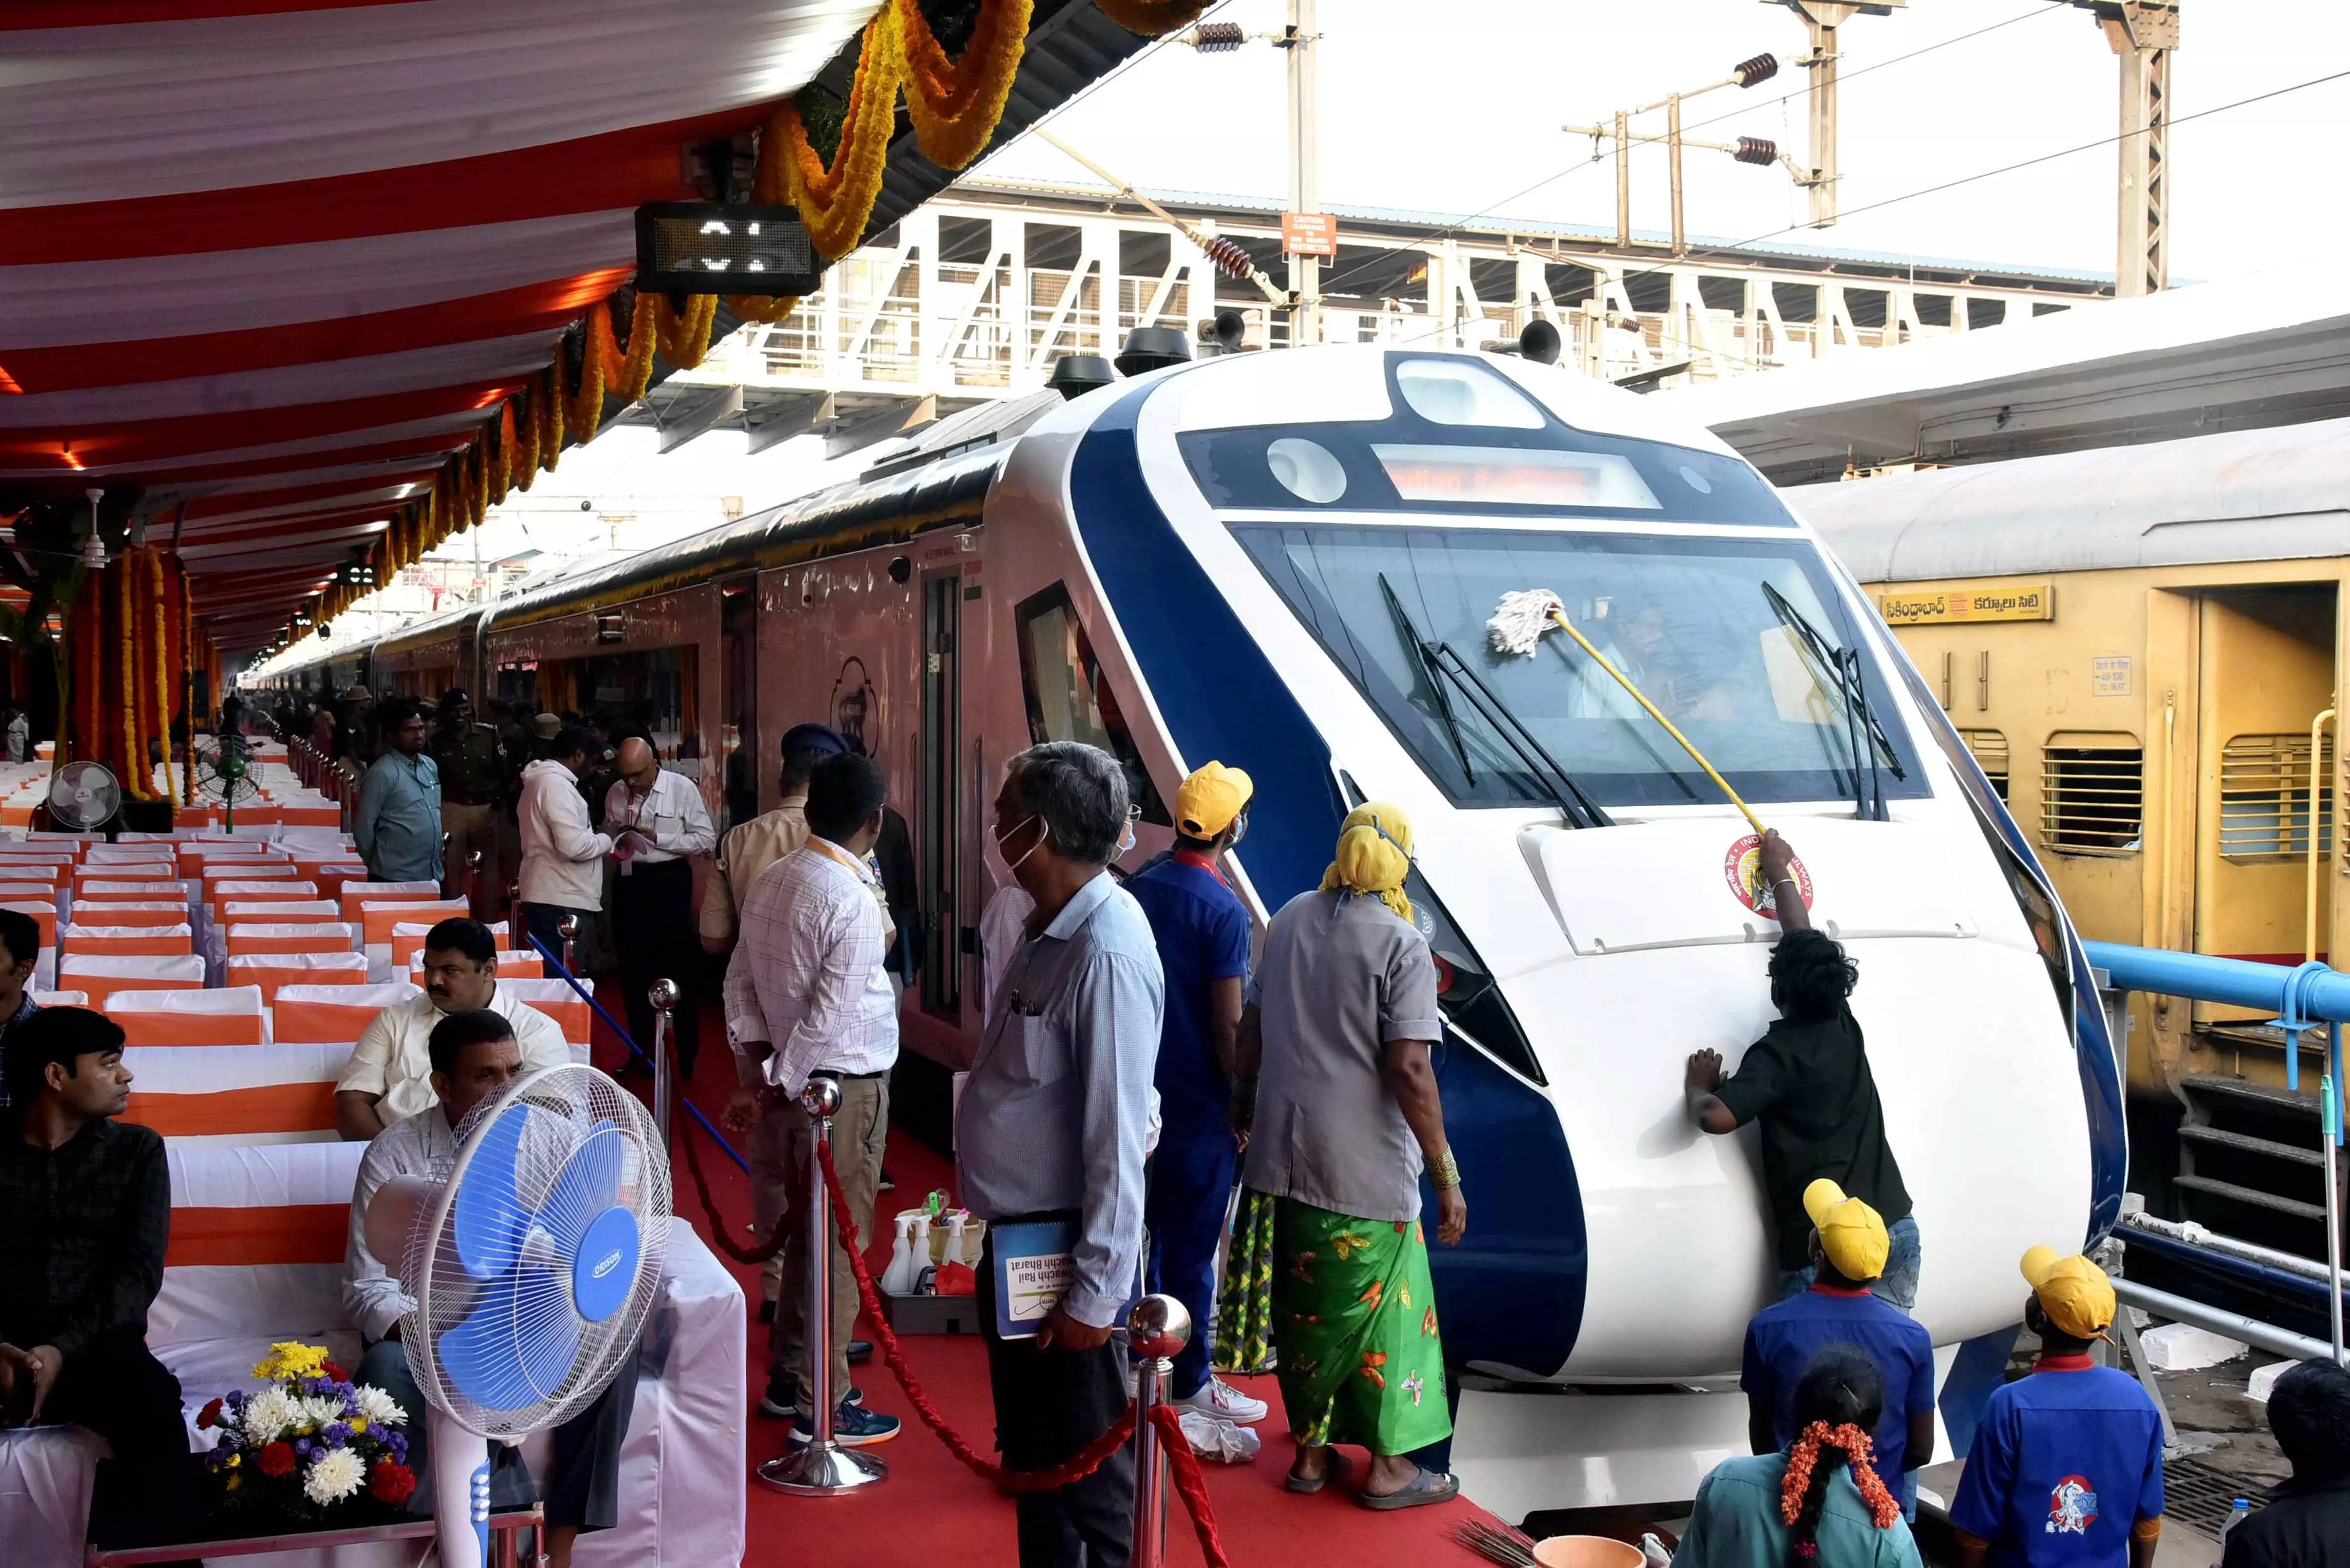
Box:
[343, 1008, 637, 1568]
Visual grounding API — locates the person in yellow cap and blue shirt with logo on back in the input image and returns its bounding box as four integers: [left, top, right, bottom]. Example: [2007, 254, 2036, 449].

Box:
[1950, 1246, 2162, 1568]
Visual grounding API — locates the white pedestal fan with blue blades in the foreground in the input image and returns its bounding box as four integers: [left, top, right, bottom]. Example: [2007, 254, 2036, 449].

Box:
[367, 1063, 670, 1568]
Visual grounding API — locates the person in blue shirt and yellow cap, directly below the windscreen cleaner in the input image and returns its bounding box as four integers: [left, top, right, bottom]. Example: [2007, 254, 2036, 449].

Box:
[1739, 1178, 1934, 1519]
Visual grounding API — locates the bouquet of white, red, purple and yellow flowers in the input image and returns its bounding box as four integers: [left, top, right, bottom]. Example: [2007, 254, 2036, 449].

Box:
[195, 1345, 416, 1523]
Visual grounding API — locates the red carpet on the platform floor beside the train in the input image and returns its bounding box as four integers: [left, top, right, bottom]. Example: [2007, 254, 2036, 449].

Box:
[597, 1001, 1485, 1568]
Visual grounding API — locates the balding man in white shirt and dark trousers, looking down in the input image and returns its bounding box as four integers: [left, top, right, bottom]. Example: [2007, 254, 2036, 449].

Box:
[604, 736, 719, 1079]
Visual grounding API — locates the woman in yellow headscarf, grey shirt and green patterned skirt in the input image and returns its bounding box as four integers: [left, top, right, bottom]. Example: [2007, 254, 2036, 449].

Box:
[1239, 802, 1469, 1509]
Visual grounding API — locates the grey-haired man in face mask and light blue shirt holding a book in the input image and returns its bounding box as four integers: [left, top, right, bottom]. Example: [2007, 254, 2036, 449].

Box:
[954, 741, 1166, 1568]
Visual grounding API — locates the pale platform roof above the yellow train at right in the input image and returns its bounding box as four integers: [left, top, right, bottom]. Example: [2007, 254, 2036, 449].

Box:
[1657, 268, 2350, 484]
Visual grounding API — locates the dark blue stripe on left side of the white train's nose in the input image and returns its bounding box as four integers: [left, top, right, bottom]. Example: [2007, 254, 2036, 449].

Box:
[1069, 383, 1589, 1373]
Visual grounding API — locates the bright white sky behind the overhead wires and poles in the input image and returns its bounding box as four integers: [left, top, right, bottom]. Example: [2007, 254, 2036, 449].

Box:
[980, 0, 2350, 282]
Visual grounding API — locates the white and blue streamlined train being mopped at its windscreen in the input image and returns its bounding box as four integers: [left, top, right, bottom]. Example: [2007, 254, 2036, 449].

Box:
[262, 346, 2124, 1512]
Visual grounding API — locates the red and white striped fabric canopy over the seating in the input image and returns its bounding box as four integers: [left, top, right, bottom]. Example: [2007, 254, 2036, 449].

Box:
[0, 0, 1145, 651]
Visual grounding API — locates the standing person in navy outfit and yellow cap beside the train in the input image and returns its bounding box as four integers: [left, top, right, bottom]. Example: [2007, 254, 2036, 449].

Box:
[1126, 762, 1267, 1425]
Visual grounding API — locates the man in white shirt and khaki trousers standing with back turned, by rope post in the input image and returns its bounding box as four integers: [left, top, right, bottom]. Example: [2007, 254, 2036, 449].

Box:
[726, 754, 898, 1446]
